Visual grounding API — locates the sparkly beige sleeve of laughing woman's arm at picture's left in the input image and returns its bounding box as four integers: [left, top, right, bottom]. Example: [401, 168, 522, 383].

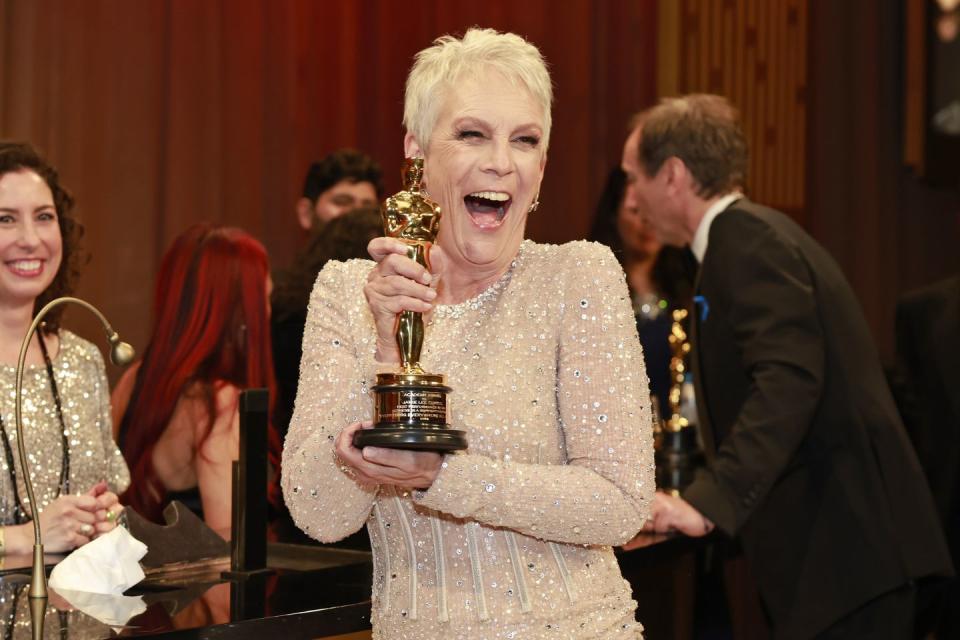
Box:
[282, 261, 376, 542]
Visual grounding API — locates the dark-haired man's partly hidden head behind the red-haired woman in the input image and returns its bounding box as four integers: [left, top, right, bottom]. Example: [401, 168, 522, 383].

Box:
[297, 149, 383, 232]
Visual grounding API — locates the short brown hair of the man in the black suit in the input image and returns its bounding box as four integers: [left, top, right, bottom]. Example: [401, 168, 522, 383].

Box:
[632, 93, 748, 198]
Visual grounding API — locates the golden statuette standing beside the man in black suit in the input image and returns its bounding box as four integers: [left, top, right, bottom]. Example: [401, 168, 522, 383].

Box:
[654, 309, 702, 495]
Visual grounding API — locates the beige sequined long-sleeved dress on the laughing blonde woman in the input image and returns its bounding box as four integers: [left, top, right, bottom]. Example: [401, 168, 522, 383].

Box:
[283, 241, 654, 640]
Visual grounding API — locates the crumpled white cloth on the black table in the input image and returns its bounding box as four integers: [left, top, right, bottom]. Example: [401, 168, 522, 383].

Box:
[50, 527, 147, 595]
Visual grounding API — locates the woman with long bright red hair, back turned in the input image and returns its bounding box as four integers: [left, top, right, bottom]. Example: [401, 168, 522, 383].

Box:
[113, 224, 279, 538]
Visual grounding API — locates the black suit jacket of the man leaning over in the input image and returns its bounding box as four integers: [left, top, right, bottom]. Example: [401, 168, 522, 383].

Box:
[683, 199, 950, 638]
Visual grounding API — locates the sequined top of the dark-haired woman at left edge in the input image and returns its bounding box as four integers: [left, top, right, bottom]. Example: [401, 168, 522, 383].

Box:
[0, 329, 130, 524]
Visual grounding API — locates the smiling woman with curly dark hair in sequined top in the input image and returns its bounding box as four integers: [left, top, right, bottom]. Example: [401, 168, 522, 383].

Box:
[0, 143, 130, 554]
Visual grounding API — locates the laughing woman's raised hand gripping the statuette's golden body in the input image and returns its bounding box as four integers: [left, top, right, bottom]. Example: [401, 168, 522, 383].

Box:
[363, 237, 443, 362]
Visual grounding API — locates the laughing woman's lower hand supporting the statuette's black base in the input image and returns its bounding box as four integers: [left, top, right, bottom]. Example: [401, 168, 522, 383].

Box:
[334, 421, 443, 489]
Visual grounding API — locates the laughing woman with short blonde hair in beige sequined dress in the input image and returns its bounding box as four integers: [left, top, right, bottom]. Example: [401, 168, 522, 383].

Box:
[283, 29, 654, 639]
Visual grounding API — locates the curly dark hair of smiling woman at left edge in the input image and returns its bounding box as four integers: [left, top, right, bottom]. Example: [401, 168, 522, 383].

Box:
[0, 141, 87, 333]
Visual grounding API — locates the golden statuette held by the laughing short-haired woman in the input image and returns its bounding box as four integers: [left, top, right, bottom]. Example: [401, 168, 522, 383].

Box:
[353, 158, 467, 451]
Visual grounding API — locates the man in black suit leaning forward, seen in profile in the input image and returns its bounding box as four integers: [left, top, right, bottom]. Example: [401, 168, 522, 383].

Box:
[623, 95, 950, 639]
